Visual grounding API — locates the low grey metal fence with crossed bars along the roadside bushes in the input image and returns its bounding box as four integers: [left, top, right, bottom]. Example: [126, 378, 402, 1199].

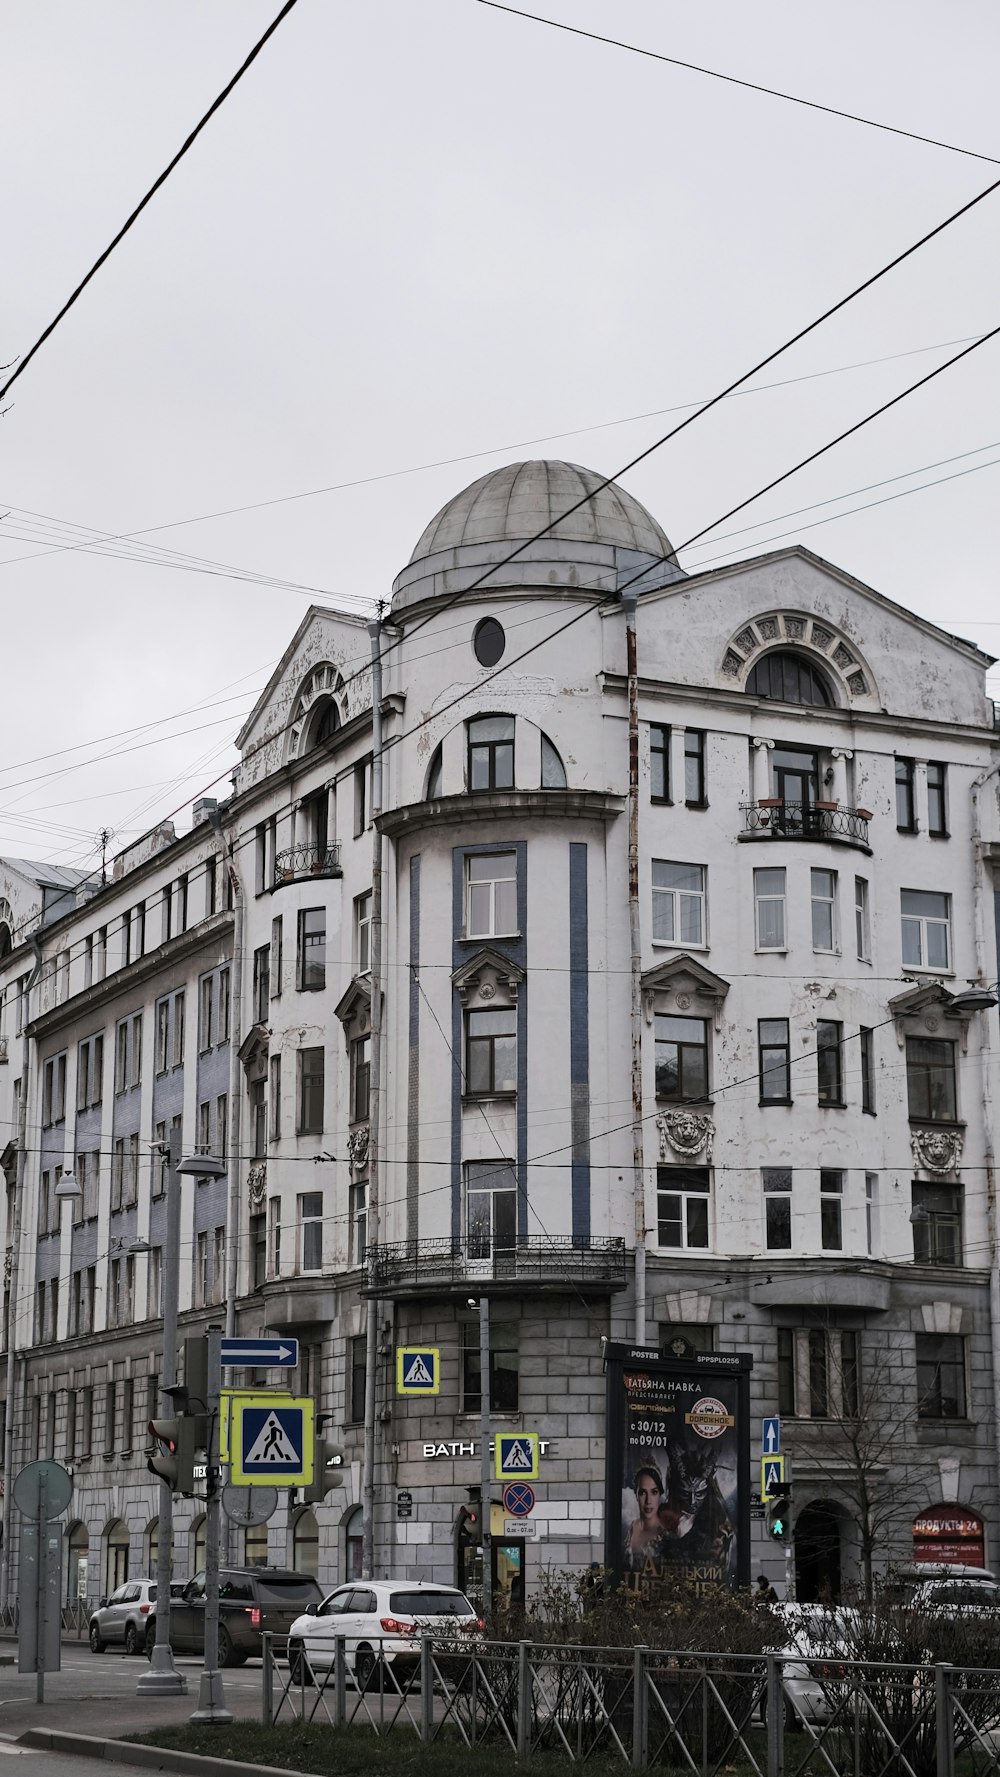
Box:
[263, 1635, 1000, 1777]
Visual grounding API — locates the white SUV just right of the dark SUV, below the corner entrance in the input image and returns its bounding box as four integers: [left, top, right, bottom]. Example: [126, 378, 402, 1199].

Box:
[288, 1580, 483, 1690]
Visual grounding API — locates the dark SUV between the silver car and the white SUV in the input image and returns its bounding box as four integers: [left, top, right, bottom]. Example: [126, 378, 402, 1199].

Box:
[146, 1567, 323, 1667]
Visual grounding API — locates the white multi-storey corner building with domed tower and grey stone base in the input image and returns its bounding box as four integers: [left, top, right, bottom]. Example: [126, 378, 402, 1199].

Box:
[0, 462, 1000, 1596]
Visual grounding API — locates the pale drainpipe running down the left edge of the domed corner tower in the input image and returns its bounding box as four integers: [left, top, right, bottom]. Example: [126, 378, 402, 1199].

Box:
[361, 618, 382, 1580]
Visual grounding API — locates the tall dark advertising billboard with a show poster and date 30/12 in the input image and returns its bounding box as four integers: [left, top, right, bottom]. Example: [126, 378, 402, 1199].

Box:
[604, 1345, 753, 1598]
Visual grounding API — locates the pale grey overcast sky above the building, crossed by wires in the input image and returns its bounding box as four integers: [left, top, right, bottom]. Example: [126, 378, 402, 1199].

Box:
[0, 0, 1000, 864]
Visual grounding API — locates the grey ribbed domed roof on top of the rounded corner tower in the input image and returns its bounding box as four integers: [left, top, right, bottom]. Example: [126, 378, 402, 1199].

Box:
[410, 460, 673, 562]
